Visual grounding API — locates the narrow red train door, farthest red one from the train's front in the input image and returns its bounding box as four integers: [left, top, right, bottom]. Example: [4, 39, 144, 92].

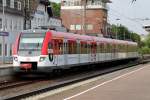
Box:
[91, 42, 97, 62]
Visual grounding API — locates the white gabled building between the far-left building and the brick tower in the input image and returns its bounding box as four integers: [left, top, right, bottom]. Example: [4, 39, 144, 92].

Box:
[31, 0, 62, 29]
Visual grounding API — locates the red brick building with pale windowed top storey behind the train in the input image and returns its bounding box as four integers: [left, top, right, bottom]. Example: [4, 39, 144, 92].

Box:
[61, 0, 111, 36]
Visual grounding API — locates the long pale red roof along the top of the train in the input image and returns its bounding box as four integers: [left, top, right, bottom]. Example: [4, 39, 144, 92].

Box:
[22, 29, 137, 45]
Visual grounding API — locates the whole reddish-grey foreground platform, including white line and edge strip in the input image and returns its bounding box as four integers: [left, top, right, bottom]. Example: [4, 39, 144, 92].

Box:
[36, 64, 150, 100]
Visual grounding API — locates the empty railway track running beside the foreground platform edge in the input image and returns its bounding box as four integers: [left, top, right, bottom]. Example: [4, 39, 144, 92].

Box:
[0, 59, 143, 100]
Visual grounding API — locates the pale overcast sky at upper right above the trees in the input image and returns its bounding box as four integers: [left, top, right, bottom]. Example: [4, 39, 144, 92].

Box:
[50, 0, 150, 34]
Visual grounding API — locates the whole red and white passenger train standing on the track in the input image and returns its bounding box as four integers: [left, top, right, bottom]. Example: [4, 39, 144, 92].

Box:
[13, 30, 139, 72]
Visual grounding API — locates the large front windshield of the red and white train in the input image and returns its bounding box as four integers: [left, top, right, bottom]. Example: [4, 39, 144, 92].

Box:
[19, 33, 45, 51]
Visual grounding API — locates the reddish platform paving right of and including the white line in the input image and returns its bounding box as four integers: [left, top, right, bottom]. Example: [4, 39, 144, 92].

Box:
[64, 65, 150, 100]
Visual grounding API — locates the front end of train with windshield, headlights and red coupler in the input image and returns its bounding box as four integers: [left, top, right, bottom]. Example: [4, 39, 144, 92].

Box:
[13, 32, 54, 73]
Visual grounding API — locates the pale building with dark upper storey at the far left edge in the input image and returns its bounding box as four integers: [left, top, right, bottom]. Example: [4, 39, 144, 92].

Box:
[0, 0, 24, 62]
